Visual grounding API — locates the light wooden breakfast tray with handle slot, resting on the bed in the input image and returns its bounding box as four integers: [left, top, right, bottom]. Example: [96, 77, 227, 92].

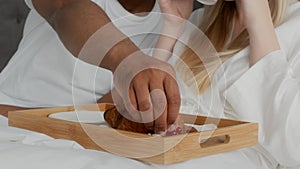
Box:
[8, 104, 258, 164]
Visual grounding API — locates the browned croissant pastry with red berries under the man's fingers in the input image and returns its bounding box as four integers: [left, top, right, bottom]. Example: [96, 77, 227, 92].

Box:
[104, 107, 197, 136]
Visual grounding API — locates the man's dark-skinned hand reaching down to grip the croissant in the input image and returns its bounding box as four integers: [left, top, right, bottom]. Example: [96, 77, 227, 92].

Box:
[112, 52, 181, 133]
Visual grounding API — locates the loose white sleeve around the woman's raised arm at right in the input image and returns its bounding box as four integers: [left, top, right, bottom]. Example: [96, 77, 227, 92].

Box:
[226, 51, 300, 166]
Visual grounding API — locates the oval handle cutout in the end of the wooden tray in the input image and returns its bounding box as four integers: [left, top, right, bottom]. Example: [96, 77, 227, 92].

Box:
[199, 135, 230, 148]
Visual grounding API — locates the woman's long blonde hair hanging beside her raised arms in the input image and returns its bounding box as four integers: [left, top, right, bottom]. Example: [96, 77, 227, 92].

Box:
[176, 0, 289, 92]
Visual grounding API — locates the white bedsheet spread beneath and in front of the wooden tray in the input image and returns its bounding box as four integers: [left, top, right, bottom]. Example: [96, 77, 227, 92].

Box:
[0, 116, 288, 169]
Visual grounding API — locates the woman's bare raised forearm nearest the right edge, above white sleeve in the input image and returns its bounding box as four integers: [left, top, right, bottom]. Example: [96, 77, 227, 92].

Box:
[236, 0, 280, 66]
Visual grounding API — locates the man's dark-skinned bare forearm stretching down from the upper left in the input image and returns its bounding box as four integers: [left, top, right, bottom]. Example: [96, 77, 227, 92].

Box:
[32, 0, 138, 71]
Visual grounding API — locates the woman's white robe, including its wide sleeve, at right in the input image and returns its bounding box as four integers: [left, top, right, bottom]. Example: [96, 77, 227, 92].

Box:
[173, 2, 300, 168]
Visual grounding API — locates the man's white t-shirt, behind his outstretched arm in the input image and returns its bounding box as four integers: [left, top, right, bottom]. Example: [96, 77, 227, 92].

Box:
[0, 0, 161, 107]
